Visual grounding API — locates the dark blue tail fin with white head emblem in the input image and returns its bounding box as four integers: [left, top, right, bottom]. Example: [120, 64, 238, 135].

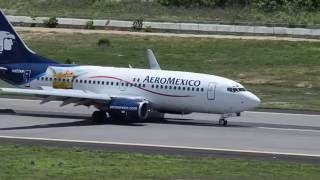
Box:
[0, 10, 57, 64]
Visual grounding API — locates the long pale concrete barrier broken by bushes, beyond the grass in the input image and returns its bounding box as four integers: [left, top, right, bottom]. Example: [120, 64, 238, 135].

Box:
[7, 16, 320, 38]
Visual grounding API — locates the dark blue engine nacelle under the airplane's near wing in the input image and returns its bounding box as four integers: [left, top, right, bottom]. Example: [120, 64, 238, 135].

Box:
[109, 98, 149, 120]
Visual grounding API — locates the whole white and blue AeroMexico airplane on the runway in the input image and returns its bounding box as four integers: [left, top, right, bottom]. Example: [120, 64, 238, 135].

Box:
[0, 11, 261, 126]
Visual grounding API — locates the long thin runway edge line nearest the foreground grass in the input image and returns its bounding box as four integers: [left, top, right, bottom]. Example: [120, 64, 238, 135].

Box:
[0, 136, 320, 158]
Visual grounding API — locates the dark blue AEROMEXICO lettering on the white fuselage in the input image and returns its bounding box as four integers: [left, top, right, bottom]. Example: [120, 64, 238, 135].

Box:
[143, 76, 201, 87]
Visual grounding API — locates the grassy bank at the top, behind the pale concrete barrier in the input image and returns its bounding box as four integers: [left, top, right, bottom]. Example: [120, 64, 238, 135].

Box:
[0, 0, 320, 26]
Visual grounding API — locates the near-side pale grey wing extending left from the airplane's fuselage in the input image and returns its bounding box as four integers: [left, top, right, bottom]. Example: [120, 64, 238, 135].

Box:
[0, 87, 111, 109]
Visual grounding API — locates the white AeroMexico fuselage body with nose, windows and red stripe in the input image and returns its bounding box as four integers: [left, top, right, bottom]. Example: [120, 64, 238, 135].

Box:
[24, 66, 260, 114]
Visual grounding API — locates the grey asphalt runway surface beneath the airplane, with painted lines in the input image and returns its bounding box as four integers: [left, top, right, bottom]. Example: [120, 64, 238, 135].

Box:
[0, 98, 320, 163]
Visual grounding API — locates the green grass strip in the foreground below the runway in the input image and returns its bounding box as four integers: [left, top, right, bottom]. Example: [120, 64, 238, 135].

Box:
[0, 145, 320, 180]
